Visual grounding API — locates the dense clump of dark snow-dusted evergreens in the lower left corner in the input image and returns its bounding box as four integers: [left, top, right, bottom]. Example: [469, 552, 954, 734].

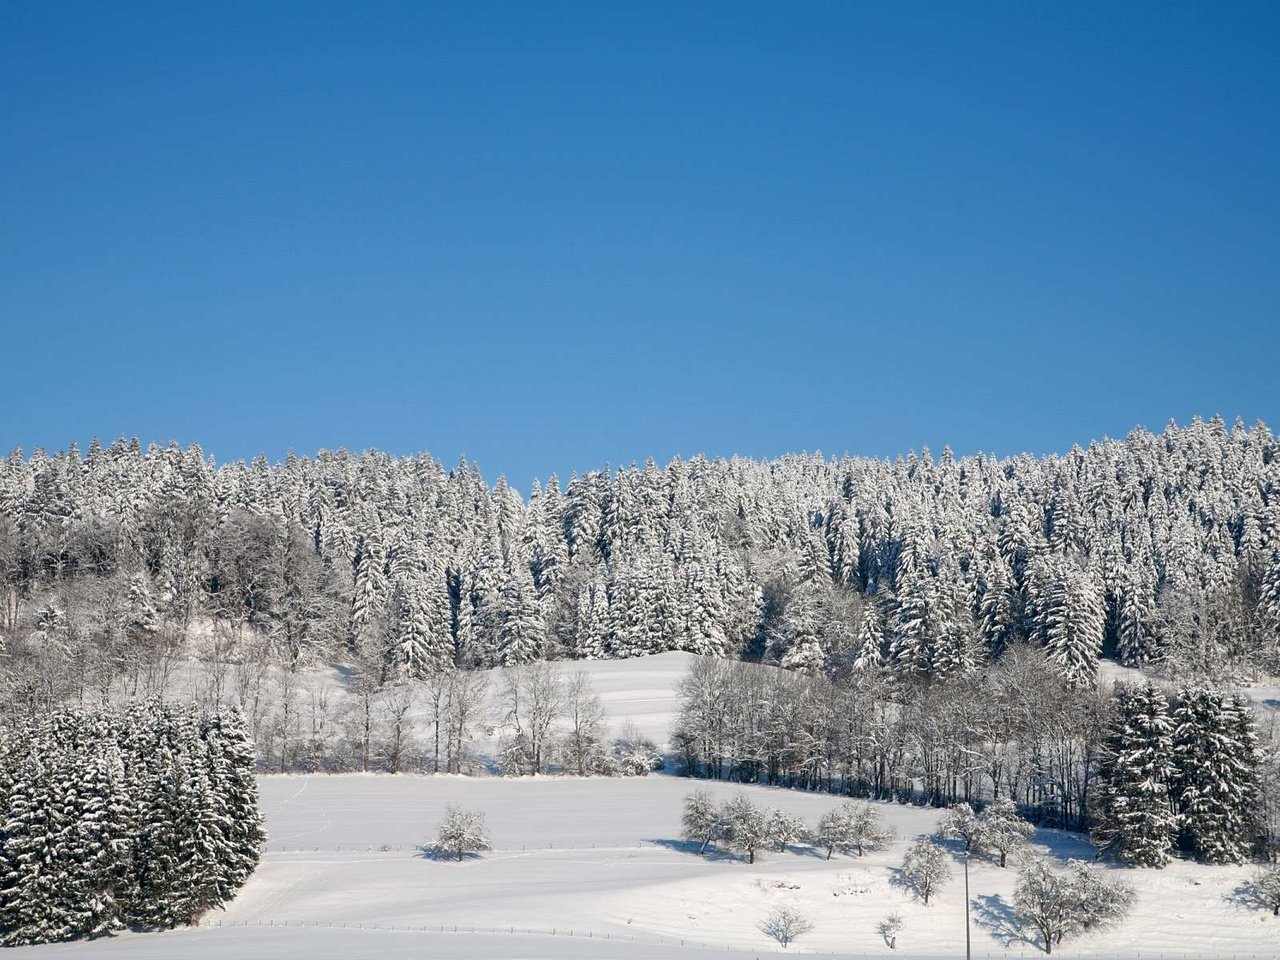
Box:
[0, 701, 265, 946]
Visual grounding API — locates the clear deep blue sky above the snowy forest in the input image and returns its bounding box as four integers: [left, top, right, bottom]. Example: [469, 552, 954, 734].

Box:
[0, 1, 1280, 488]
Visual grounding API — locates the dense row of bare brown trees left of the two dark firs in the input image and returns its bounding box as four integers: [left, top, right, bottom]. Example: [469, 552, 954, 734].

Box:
[672, 646, 1108, 829]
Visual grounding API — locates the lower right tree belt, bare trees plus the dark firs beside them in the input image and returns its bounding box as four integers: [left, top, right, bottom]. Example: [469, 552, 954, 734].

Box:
[672, 646, 1280, 863]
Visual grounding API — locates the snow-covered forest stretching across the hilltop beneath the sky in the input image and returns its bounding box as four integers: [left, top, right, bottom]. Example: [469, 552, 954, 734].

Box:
[0, 419, 1280, 762]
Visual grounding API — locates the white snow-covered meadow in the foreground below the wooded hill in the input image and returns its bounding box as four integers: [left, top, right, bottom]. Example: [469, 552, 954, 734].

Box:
[9, 654, 1280, 960]
